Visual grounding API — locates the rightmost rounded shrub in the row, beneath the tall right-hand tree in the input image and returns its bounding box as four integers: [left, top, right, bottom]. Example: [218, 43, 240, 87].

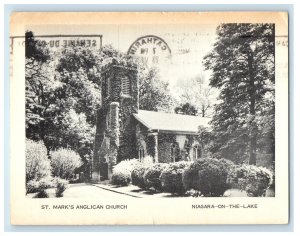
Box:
[230, 164, 273, 197]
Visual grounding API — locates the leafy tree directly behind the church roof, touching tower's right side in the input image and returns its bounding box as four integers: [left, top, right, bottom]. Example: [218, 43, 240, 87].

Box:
[139, 66, 173, 112]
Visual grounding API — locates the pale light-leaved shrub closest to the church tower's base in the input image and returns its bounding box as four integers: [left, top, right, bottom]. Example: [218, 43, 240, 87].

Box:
[111, 159, 139, 186]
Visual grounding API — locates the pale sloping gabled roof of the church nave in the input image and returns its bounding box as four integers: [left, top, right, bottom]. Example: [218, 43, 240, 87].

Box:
[133, 110, 210, 134]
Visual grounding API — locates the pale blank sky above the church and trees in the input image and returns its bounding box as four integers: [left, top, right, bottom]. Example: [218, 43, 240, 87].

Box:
[21, 24, 217, 91]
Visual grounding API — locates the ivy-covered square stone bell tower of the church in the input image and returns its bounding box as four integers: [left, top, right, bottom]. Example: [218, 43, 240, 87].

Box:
[92, 60, 139, 182]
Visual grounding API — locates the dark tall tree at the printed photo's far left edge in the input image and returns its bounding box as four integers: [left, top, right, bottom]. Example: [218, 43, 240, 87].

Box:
[25, 31, 59, 154]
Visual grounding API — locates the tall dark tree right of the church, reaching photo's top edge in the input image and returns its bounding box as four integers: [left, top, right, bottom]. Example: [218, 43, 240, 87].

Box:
[204, 24, 275, 165]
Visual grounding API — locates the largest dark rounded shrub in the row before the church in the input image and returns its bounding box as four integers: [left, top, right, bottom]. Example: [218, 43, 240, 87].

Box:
[183, 158, 234, 197]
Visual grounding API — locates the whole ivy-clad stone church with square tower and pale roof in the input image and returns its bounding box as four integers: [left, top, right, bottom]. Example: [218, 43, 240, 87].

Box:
[92, 62, 209, 182]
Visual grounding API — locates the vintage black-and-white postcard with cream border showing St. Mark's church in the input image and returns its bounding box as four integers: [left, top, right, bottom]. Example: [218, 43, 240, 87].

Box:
[10, 12, 289, 225]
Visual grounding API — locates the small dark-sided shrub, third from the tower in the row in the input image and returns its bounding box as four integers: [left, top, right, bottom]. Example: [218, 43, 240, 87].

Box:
[143, 163, 168, 192]
